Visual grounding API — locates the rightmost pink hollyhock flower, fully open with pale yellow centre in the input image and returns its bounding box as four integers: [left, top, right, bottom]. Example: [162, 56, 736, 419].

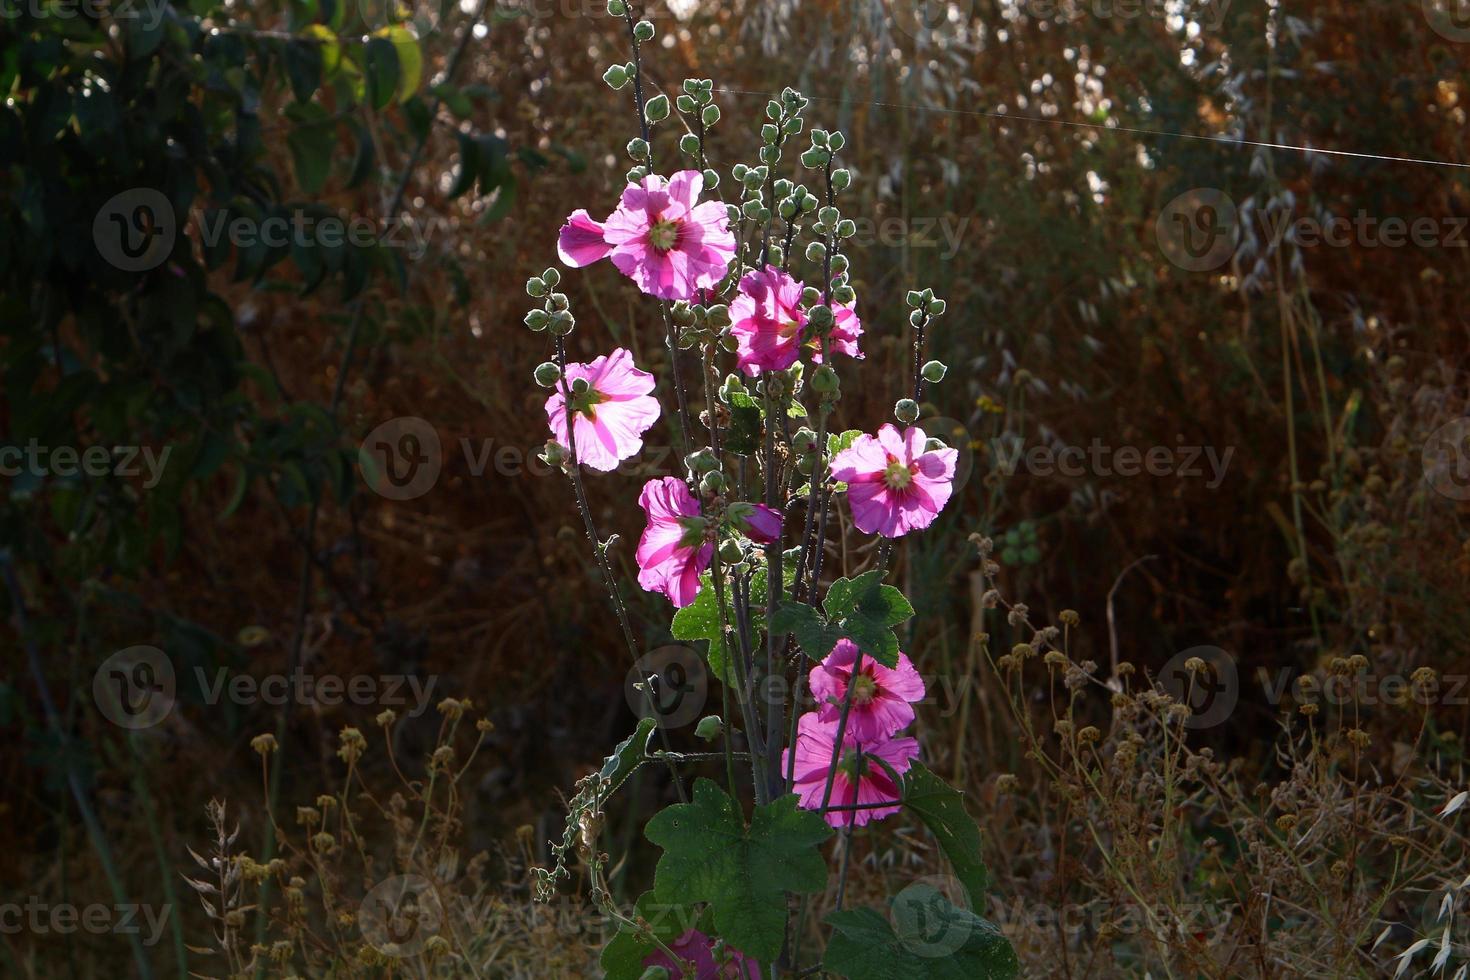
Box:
[831, 425, 960, 538]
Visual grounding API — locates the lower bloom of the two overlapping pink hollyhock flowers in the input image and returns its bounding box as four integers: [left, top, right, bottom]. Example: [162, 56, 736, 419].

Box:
[781, 711, 919, 827]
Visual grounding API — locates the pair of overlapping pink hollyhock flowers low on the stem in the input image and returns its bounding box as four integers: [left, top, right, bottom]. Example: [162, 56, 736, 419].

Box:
[781, 639, 925, 827]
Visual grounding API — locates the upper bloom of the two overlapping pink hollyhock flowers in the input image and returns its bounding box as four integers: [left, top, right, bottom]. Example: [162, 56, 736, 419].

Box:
[810, 639, 923, 742]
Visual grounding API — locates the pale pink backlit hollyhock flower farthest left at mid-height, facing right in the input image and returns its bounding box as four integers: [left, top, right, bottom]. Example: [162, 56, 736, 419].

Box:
[547, 347, 659, 473]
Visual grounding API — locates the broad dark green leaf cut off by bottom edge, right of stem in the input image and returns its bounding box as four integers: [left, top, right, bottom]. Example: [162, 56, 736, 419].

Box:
[822, 905, 1020, 980]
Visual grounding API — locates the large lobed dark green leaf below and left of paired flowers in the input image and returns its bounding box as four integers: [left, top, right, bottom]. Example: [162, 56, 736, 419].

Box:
[644, 779, 832, 962]
